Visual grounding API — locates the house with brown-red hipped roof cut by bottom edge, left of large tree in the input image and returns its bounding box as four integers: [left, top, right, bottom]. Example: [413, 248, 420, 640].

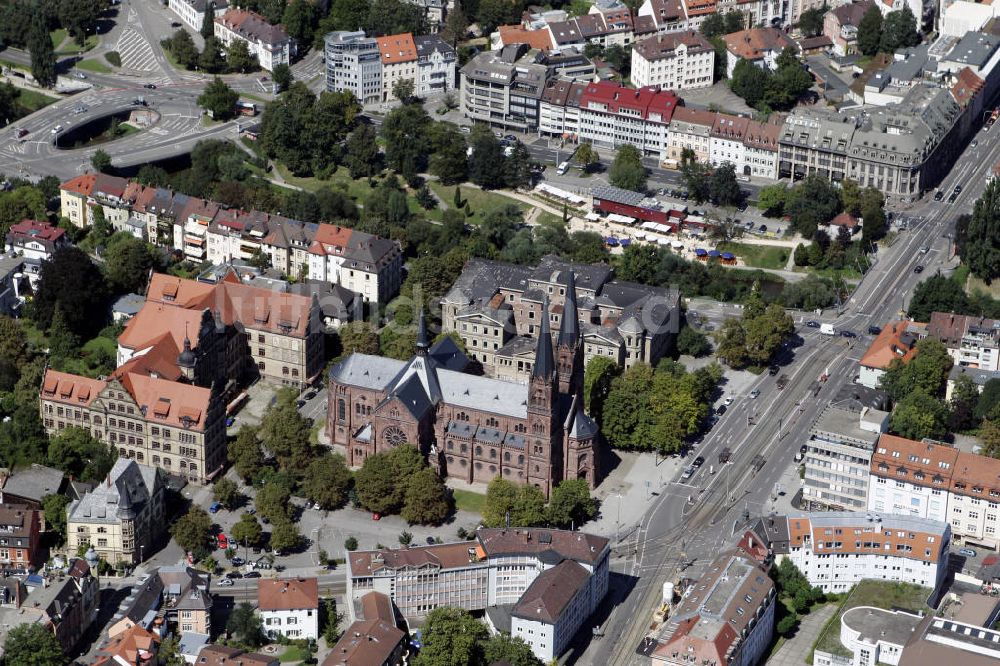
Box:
[322, 592, 406, 666]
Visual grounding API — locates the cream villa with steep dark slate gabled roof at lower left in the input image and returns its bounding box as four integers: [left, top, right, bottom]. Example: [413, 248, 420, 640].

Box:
[66, 458, 166, 565]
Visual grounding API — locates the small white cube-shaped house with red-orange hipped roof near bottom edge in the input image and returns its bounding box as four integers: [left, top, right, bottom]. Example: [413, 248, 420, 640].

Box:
[257, 578, 319, 640]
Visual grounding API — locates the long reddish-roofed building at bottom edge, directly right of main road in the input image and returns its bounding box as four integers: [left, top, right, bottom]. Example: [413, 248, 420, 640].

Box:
[650, 549, 777, 666]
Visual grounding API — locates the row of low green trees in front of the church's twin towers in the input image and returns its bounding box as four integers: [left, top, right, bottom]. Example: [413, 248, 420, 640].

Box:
[483, 477, 597, 529]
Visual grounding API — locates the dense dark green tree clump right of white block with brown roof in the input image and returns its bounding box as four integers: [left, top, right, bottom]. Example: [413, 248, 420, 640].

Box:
[729, 46, 813, 113]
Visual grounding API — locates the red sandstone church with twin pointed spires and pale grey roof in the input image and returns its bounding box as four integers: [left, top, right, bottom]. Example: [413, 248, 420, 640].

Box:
[327, 274, 601, 495]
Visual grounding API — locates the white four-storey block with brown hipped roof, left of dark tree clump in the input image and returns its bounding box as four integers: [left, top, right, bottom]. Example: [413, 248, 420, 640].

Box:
[630, 31, 715, 90]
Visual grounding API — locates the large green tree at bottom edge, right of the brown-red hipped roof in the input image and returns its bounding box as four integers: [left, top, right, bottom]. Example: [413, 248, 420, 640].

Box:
[413, 604, 488, 666]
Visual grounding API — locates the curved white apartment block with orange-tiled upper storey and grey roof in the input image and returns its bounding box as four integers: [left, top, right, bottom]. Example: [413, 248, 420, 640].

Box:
[778, 511, 951, 593]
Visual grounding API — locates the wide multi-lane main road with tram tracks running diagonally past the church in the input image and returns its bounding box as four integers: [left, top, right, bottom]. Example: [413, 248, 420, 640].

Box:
[580, 118, 1000, 666]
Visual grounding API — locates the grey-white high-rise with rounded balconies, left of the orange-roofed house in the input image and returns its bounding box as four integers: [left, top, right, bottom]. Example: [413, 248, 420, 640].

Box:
[324, 30, 382, 104]
